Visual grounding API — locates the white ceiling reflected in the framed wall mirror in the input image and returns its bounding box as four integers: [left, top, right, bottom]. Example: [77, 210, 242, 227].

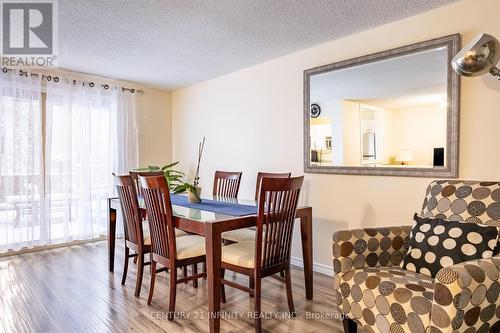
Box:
[310, 47, 449, 108]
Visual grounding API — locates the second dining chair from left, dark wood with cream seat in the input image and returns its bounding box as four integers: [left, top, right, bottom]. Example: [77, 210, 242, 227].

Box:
[139, 176, 206, 320]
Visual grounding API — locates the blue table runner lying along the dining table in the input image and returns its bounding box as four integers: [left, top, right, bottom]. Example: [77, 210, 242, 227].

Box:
[170, 194, 257, 216]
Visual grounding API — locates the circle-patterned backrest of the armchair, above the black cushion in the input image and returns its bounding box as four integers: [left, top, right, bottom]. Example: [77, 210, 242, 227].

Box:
[421, 180, 500, 226]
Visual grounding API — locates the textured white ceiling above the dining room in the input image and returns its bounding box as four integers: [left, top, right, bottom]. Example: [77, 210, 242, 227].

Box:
[58, 0, 457, 89]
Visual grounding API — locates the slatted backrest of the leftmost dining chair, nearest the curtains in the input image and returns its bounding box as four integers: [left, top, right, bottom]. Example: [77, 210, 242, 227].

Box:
[114, 175, 144, 246]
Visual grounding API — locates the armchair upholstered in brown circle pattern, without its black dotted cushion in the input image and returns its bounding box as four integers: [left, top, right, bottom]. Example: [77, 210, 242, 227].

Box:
[333, 180, 500, 333]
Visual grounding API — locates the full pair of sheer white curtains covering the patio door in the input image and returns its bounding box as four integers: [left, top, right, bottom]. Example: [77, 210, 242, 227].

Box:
[0, 71, 138, 252]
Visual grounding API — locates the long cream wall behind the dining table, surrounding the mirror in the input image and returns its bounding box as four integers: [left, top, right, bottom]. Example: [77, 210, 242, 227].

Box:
[173, 0, 500, 267]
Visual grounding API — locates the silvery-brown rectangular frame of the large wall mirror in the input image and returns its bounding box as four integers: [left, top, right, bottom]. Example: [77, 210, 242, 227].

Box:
[304, 34, 460, 178]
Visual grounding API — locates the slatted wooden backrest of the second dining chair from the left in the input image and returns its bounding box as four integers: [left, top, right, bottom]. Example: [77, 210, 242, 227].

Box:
[139, 176, 176, 260]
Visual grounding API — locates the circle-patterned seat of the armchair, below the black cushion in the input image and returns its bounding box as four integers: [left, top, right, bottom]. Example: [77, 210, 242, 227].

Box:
[335, 266, 434, 332]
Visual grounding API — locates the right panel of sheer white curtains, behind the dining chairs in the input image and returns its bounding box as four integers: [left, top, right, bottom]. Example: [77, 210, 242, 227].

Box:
[45, 81, 138, 242]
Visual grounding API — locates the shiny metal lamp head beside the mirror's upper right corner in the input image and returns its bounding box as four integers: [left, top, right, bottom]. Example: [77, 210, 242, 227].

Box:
[451, 33, 500, 80]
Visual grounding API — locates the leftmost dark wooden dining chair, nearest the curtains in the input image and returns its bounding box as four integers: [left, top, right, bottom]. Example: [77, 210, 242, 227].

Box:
[113, 175, 151, 297]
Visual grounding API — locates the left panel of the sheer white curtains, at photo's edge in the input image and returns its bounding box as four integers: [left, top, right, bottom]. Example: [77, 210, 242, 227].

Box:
[0, 71, 42, 252]
